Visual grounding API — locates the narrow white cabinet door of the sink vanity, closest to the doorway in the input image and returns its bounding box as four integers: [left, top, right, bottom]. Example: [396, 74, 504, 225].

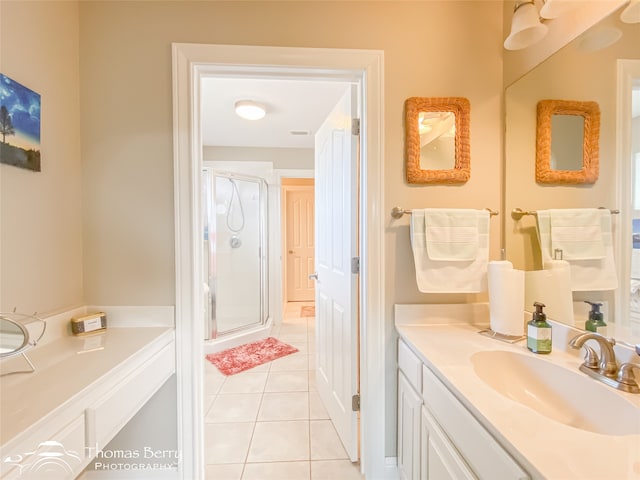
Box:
[398, 371, 422, 480]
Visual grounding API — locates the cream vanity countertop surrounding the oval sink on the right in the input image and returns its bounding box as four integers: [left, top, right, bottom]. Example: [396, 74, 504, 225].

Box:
[395, 305, 640, 480]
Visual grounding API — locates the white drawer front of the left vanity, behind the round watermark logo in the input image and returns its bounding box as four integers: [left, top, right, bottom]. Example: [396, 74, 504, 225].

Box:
[2, 415, 86, 480]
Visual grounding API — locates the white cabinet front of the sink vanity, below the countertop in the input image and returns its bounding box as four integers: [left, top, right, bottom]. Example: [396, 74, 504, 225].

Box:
[398, 340, 530, 480]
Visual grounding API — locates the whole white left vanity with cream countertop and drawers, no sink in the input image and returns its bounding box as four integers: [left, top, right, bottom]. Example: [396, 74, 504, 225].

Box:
[0, 327, 175, 480]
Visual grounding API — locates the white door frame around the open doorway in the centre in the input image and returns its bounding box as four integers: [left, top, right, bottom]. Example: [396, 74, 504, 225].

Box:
[172, 43, 384, 480]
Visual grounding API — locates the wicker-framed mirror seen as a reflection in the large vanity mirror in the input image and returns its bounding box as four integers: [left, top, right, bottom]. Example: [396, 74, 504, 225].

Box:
[536, 100, 600, 184]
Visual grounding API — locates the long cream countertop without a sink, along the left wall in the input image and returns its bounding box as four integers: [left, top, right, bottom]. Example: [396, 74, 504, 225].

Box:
[0, 327, 174, 446]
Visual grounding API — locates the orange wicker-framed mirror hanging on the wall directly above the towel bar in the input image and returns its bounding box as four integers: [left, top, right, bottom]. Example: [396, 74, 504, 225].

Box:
[405, 97, 471, 185]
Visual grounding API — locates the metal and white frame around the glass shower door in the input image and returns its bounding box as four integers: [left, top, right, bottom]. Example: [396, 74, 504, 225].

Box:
[202, 166, 269, 340]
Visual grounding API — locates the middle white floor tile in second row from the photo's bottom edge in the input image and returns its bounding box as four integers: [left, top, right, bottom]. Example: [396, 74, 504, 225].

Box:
[247, 421, 309, 463]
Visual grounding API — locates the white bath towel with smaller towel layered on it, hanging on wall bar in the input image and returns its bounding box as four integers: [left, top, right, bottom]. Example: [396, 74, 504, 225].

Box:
[410, 209, 490, 293]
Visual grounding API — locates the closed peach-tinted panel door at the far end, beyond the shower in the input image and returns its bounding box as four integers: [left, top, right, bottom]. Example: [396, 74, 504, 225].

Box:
[285, 186, 315, 302]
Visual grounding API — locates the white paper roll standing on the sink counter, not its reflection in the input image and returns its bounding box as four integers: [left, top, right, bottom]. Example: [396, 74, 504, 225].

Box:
[487, 260, 524, 336]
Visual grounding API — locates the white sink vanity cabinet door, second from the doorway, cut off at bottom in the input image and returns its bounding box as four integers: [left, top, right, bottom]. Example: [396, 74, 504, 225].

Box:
[420, 407, 477, 480]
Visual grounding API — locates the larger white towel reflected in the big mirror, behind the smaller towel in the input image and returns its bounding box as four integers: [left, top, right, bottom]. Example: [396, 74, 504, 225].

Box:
[536, 209, 618, 292]
